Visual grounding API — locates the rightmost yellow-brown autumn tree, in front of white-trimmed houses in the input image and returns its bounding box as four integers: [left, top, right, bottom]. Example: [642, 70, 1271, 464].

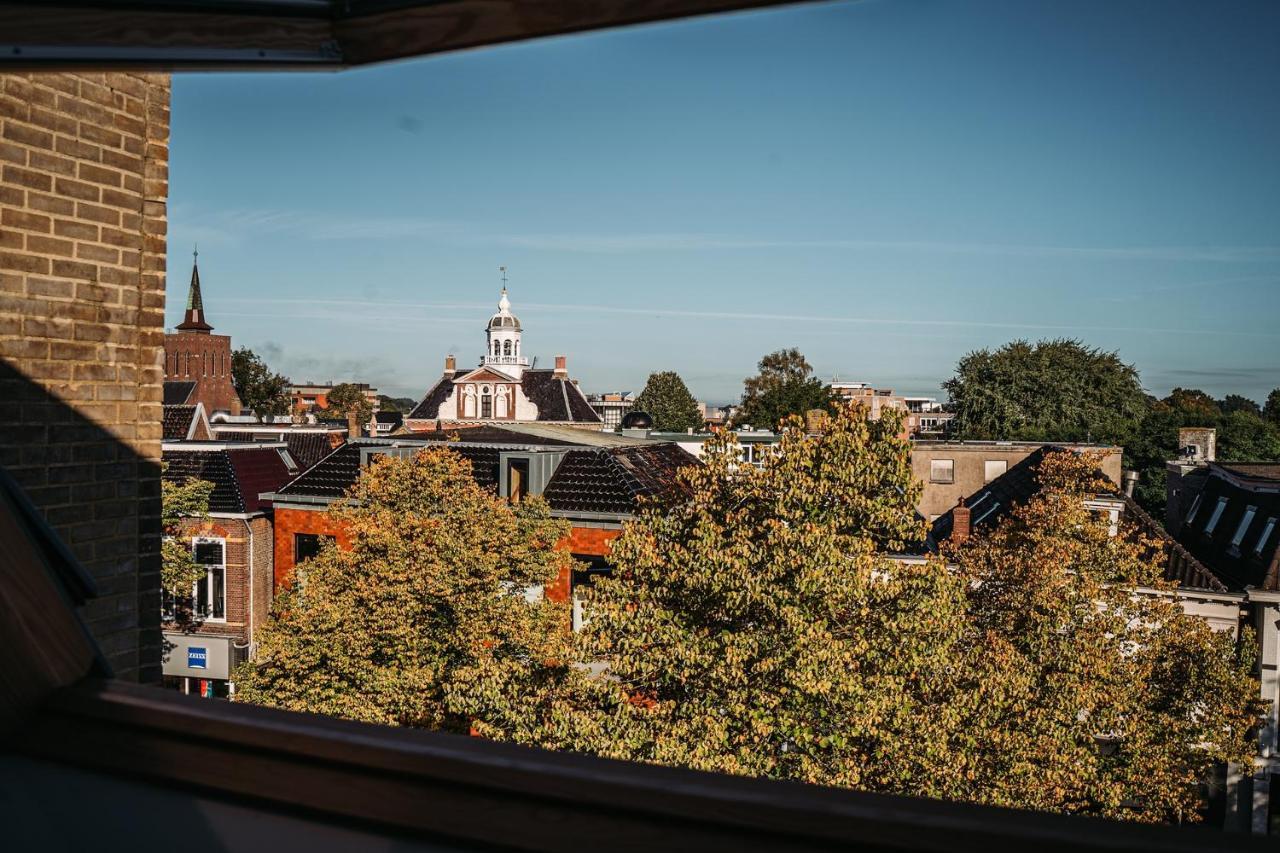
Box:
[947, 452, 1261, 822]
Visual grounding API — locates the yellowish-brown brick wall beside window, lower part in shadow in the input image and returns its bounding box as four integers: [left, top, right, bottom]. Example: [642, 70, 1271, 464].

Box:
[0, 73, 169, 680]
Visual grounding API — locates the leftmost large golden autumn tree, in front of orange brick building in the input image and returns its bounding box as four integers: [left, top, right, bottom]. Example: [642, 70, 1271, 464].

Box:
[236, 447, 581, 743]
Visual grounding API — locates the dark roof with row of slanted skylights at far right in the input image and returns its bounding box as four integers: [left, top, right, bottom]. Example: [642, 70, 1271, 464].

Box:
[1178, 462, 1280, 590]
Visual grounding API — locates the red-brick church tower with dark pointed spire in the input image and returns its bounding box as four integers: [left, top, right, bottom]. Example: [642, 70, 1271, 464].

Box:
[164, 251, 241, 415]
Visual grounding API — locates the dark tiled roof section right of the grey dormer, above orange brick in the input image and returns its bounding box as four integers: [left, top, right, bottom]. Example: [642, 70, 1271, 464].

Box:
[543, 443, 698, 515]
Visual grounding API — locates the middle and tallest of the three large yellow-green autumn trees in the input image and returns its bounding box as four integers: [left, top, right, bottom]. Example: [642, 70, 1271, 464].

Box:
[563, 407, 964, 790]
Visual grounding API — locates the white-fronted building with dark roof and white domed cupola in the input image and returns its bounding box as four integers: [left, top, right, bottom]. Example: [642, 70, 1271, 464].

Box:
[404, 287, 603, 432]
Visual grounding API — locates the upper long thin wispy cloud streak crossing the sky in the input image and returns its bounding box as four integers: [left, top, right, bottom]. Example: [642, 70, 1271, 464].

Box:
[172, 207, 1280, 263]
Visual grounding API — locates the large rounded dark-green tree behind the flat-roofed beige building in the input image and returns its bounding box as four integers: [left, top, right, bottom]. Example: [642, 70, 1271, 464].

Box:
[942, 339, 1147, 444]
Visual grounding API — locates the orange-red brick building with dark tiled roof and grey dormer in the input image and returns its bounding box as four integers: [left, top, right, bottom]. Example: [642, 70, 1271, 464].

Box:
[261, 425, 698, 617]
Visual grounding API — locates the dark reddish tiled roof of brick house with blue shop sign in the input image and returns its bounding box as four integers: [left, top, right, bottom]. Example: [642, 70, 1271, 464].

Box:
[163, 447, 289, 512]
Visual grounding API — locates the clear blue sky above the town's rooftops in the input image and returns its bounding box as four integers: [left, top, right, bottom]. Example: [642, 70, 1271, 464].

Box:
[168, 0, 1280, 402]
